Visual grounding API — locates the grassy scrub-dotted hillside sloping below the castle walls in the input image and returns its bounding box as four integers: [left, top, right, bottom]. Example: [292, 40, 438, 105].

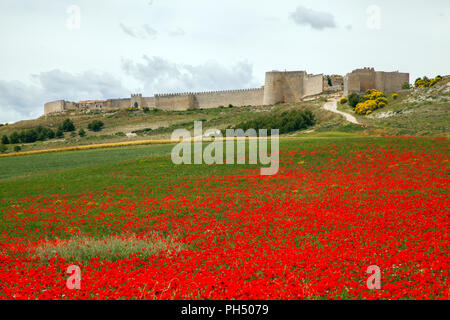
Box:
[0, 82, 450, 152]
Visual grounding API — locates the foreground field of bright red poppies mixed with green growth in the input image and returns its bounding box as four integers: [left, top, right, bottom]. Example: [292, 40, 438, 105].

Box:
[0, 138, 450, 300]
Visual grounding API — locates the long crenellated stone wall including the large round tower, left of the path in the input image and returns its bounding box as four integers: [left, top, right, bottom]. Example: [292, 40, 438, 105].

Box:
[44, 71, 324, 115]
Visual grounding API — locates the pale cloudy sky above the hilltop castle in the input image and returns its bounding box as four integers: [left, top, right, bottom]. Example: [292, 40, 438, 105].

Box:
[0, 0, 450, 123]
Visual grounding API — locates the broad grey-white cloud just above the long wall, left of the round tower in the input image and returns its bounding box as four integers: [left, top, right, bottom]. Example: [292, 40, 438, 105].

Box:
[122, 56, 261, 95]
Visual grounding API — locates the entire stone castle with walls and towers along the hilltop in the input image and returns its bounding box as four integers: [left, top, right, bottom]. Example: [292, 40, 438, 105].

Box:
[44, 68, 409, 115]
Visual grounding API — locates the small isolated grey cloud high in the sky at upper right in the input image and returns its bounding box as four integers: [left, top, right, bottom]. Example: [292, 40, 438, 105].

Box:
[290, 6, 336, 30]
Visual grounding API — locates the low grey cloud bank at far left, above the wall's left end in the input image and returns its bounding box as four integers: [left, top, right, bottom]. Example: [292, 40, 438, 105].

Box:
[0, 70, 130, 122]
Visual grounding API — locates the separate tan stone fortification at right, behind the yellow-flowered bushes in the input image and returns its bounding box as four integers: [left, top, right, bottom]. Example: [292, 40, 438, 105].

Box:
[344, 68, 409, 95]
